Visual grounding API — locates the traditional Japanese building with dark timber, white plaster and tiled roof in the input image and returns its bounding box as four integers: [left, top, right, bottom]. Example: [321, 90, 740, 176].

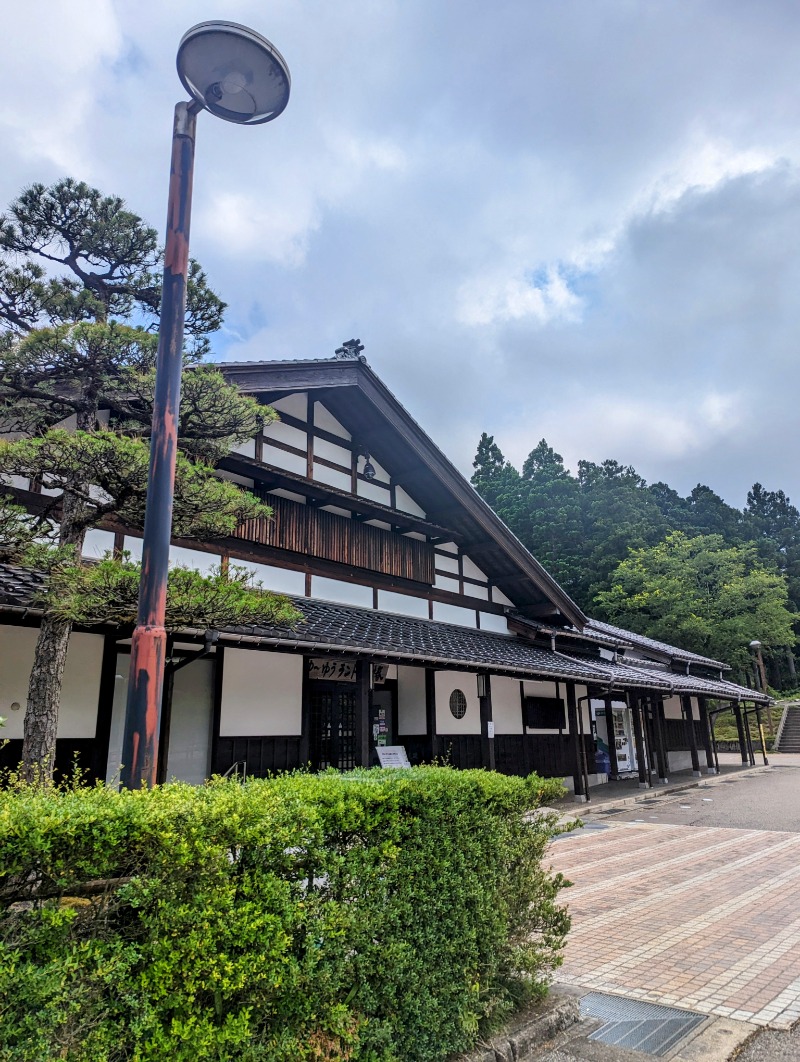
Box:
[0, 344, 767, 798]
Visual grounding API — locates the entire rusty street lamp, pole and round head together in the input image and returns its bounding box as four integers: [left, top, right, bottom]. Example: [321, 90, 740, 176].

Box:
[122, 21, 291, 789]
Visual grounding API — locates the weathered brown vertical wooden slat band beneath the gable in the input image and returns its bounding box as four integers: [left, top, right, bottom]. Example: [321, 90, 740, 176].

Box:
[236, 492, 435, 585]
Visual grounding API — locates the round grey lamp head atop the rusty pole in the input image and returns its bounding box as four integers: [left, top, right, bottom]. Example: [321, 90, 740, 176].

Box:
[177, 21, 291, 125]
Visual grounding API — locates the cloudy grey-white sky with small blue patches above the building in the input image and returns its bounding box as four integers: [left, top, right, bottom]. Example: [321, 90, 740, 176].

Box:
[0, 0, 800, 506]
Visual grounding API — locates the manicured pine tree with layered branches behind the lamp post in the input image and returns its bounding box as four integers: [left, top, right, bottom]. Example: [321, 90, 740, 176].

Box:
[0, 179, 291, 781]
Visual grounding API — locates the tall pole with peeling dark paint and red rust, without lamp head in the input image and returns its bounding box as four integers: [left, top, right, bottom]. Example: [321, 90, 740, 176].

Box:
[121, 103, 201, 789]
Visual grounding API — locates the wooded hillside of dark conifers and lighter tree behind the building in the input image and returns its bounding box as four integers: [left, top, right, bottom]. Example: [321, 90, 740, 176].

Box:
[472, 433, 800, 686]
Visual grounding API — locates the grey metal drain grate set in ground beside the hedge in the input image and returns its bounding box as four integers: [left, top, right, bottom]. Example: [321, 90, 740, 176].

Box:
[580, 992, 705, 1058]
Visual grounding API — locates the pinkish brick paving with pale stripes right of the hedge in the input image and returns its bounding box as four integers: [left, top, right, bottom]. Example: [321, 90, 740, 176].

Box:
[550, 823, 800, 1029]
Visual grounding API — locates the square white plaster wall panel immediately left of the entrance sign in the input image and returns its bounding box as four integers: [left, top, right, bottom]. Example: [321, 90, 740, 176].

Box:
[220, 649, 303, 737]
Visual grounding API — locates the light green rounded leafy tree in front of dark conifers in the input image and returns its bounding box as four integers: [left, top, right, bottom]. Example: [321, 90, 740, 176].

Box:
[595, 531, 796, 669]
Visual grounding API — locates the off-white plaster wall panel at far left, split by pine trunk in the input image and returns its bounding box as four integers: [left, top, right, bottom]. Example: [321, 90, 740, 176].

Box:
[0, 626, 103, 739]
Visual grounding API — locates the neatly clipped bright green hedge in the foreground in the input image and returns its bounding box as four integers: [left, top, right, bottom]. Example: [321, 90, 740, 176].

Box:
[0, 768, 568, 1062]
